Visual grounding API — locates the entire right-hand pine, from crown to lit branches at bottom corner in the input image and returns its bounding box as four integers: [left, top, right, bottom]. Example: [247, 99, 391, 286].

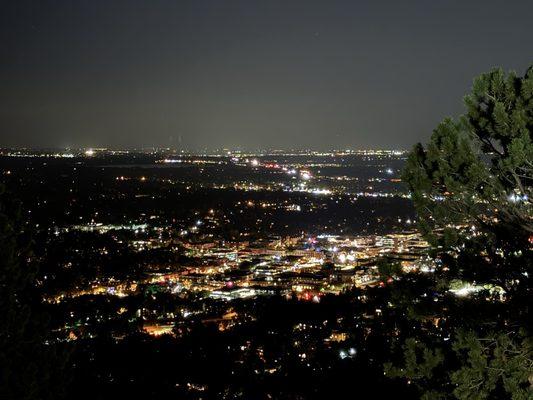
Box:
[385, 65, 533, 400]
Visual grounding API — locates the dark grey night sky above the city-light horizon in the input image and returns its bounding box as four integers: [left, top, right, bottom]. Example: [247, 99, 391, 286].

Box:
[0, 0, 533, 149]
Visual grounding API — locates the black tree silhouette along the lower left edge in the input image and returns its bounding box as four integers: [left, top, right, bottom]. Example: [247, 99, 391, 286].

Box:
[0, 186, 65, 400]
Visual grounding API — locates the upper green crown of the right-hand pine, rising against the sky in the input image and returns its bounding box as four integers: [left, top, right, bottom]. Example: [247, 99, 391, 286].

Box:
[404, 66, 533, 247]
